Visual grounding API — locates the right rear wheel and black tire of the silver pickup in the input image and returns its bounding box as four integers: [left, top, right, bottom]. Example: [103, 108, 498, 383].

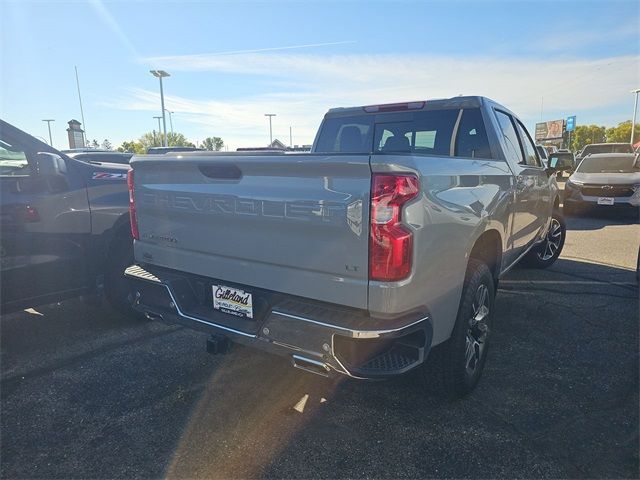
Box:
[424, 258, 496, 400]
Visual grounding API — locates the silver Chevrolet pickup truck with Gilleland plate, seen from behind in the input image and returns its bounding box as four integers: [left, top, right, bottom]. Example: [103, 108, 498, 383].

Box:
[125, 97, 565, 396]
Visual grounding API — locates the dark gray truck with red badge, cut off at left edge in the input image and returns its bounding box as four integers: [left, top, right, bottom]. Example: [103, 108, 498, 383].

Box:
[0, 120, 133, 313]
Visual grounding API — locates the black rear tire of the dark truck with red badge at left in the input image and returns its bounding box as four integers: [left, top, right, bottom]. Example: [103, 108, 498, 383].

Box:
[104, 235, 145, 320]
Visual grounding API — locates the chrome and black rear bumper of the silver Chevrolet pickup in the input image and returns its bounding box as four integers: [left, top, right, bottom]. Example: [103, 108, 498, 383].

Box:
[125, 265, 433, 378]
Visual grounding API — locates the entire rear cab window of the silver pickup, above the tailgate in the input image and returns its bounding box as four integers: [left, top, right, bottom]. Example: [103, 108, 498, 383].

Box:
[315, 108, 491, 158]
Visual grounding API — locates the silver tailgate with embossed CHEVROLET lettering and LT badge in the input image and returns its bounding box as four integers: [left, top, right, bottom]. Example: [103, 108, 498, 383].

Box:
[132, 154, 371, 308]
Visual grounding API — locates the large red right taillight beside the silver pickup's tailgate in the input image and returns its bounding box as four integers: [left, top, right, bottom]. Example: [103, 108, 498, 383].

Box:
[369, 173, 420, 282]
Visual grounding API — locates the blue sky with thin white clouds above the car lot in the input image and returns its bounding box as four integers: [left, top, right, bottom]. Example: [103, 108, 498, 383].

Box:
[0, 0, 640, 149]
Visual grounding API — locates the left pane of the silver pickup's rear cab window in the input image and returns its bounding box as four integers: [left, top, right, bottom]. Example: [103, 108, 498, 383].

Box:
[316, 115, 373, 153]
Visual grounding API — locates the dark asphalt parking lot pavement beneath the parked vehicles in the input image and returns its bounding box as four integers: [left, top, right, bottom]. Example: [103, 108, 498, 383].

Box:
[0, 209, 640, 478]
